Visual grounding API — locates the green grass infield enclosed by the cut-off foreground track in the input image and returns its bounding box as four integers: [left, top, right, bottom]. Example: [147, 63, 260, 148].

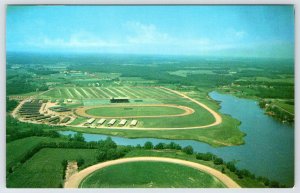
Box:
[80, 162, 224, 188]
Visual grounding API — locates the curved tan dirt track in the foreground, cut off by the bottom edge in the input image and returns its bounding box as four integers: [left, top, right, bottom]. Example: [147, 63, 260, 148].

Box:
[64, 157, 240, 188]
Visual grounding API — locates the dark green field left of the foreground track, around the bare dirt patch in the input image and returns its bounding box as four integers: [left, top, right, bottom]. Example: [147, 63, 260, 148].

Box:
[7, 148, 97, 188]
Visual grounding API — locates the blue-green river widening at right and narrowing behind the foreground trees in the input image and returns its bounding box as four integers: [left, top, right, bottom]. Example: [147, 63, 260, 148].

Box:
[60, 92, 294, 186]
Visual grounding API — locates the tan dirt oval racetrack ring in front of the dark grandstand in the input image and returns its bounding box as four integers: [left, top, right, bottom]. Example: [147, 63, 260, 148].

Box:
[76, 104, 195, 119]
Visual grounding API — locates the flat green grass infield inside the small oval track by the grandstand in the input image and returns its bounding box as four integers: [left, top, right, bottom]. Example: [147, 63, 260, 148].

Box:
[86, 106, 185, 117]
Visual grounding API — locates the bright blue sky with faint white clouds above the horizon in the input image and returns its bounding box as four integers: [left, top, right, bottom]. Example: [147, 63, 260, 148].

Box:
[6, 6, 294, 58]
